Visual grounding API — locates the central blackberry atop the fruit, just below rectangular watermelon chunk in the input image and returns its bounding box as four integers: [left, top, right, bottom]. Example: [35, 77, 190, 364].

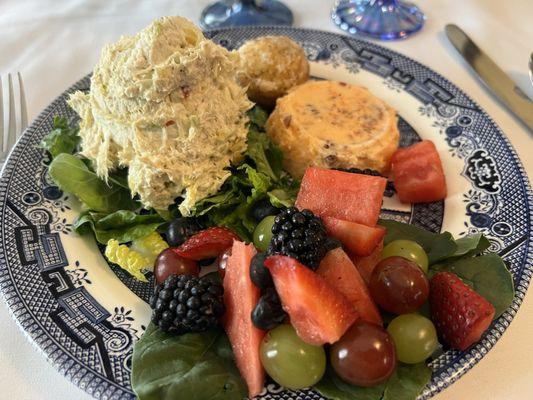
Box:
[268, 207, 327, 270]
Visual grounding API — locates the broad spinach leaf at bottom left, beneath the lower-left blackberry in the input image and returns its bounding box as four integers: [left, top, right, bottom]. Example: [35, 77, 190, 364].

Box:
[131, 324, 247, 400]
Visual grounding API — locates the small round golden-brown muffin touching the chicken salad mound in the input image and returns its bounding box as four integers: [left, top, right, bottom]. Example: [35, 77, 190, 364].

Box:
[239, 36, 309, 109]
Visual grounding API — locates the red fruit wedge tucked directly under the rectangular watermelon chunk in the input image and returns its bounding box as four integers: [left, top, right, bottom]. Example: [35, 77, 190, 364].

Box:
[322, 217, 386, 256]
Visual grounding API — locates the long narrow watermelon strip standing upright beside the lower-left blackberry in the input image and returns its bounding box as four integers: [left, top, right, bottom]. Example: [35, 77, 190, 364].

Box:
[223, 241, 265, 398]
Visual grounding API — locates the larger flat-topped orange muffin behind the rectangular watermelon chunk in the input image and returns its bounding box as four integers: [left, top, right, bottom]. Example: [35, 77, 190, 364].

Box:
[267, 80, 400, 178]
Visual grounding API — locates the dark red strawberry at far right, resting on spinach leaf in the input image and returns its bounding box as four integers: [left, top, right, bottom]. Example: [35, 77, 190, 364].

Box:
[429, 272, 495, 350]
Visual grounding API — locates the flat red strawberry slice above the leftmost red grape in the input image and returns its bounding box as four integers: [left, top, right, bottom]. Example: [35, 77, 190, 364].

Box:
[172, 226, 239, 261]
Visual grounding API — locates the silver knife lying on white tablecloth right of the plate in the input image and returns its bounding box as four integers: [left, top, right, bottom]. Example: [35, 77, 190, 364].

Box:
[445, 24, 533, 131]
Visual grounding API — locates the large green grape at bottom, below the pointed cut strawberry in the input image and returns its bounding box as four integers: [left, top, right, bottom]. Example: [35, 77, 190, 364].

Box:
[259, 324, 326, 390]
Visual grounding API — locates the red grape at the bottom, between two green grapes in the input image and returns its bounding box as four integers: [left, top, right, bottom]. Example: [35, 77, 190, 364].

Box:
[330, 320, 396, 387]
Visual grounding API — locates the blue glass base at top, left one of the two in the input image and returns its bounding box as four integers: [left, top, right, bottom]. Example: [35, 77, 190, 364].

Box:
[200, 0, 294, 29]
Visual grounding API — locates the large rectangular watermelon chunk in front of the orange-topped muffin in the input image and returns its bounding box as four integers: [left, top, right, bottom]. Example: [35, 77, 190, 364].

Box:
[296, 167, 387, 226]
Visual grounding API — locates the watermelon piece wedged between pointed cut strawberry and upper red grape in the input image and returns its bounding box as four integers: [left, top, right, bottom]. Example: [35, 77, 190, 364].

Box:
[316, 248, 383, 325]
